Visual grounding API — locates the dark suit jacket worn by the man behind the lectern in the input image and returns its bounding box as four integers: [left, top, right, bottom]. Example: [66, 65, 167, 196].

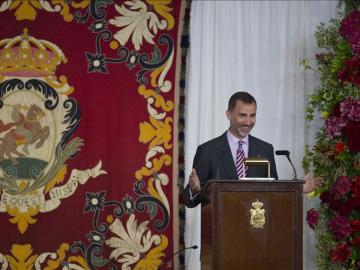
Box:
[183, 132, 278, 207]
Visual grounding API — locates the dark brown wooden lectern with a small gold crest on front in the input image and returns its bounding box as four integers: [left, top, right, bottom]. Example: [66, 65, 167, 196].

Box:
[201, 180, 304, 270]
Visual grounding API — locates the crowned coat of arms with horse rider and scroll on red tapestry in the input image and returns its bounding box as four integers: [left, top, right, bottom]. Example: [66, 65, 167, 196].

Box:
[0, 29, 106, 233]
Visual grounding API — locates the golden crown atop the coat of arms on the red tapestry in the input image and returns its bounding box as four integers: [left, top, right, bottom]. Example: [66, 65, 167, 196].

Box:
[0, 28, 67, 77]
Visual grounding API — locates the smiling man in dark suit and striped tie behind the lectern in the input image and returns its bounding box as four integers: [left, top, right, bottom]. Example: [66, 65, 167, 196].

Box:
[183, 92, 278, 207]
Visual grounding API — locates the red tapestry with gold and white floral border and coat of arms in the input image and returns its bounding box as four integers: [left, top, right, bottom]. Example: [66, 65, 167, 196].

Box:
[0, 0, 183, 270]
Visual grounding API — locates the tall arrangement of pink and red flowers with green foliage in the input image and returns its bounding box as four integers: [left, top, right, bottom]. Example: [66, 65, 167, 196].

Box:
[303, 5, 360, 270]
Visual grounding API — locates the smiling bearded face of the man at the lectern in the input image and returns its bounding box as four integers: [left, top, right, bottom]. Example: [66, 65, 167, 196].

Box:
[226, 100, 256, 139]
